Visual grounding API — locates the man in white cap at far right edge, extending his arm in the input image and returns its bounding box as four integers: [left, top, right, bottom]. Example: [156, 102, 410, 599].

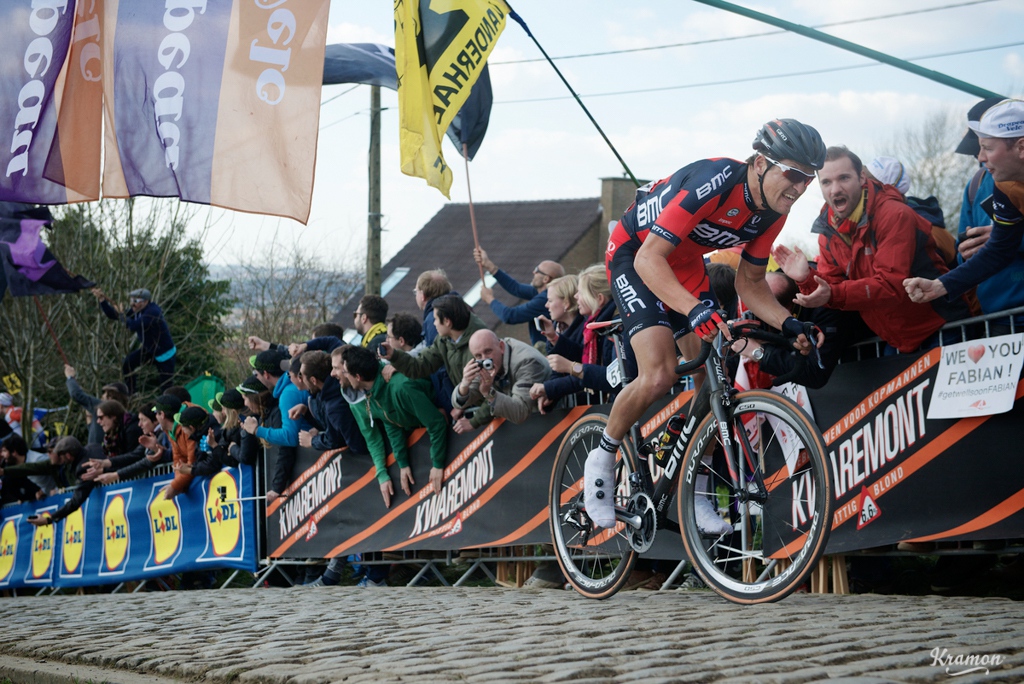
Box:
[904, 99, 1024, 302]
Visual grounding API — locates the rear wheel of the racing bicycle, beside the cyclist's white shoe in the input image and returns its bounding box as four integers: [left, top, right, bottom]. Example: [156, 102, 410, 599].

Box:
[549, 414, 637, 599]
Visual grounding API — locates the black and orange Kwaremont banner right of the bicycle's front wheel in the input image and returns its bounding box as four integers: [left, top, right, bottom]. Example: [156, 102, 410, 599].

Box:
[810, 350, 1024, 553]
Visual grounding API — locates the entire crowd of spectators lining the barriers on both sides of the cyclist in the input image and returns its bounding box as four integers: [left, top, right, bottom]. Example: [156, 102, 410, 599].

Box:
[0, 99, 1024, 587]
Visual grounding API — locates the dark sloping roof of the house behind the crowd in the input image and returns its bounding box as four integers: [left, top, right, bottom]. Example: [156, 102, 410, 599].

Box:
[334, 198, 600, 328]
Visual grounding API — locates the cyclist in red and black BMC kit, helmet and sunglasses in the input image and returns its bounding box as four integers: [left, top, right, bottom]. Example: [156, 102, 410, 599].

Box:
[584, 119, 825, 533]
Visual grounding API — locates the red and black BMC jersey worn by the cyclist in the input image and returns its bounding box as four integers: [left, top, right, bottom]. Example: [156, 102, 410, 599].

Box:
[607, 158, 785, 273]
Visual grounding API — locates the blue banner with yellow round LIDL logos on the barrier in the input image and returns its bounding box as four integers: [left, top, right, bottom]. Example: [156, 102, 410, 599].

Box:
[0, 466, 259, 589]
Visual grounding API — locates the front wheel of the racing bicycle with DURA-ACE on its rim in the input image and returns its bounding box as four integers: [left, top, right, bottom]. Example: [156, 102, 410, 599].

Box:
[677, 390, 833, 604]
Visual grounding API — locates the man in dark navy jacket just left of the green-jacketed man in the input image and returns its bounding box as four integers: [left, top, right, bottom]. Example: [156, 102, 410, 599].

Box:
[299, 350, 369, 454]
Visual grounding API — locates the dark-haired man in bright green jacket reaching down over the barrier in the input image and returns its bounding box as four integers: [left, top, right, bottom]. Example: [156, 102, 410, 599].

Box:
[341, 346, 447, 506]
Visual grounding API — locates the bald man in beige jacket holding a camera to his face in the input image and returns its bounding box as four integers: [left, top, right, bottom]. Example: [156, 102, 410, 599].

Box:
[452, 330, 551, 433]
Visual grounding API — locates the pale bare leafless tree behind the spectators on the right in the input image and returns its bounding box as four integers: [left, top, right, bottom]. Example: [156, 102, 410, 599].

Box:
[880, 109, 978, 231]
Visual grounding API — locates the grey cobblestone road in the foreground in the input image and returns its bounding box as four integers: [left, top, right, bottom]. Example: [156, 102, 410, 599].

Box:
[0, 587, 1024, 684]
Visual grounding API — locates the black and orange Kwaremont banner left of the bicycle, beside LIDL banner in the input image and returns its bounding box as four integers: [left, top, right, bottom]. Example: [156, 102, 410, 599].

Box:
[266, 392, 689, 558]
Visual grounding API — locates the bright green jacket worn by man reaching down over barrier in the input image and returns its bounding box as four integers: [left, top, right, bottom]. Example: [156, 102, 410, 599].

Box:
[352, 366, 447, 482]
